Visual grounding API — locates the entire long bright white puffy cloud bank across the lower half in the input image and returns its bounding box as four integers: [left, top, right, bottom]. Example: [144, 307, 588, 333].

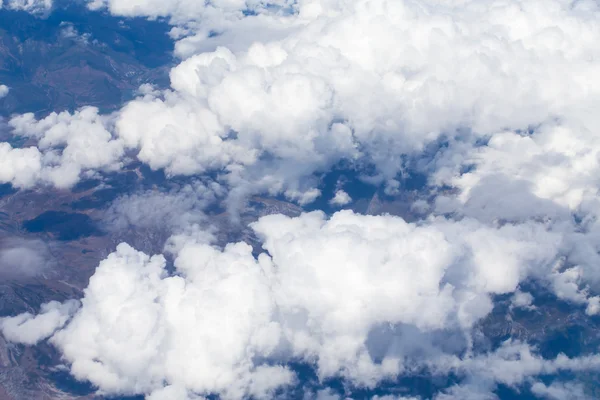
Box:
[4, 211, 584, 398]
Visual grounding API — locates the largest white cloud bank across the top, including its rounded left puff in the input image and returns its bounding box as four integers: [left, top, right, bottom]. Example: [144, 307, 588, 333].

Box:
[2, 0, 600, 204]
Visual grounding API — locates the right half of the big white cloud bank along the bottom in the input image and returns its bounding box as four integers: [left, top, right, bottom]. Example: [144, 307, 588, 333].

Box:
[248, 211, 557, 384]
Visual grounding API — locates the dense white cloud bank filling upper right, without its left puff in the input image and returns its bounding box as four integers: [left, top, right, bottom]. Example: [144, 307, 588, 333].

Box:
[119, 1, 600, 212]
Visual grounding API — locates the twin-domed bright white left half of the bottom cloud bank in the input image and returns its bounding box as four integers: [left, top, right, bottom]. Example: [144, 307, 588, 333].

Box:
[52, 244, 291, 398]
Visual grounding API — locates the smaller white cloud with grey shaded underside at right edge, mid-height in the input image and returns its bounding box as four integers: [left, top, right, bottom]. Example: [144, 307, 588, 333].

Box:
[436, 119, 600, 219]
